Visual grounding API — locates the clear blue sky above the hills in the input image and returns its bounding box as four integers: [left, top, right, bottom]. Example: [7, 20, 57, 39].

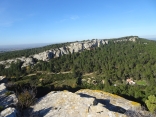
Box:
[0, 0, 156, 45]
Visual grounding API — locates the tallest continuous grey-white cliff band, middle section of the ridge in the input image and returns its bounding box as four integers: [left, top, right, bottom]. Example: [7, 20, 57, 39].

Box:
[32, 39, 108, 61]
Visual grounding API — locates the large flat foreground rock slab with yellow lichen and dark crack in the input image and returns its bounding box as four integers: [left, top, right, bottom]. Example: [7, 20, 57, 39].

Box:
[28, 89, 140, 117]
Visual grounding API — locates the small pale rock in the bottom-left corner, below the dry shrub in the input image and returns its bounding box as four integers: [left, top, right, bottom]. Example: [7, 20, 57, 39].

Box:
[0, 108, 18, 117]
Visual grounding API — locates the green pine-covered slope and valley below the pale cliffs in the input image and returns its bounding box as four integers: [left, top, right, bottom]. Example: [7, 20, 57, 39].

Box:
[0, 38, 156, 113]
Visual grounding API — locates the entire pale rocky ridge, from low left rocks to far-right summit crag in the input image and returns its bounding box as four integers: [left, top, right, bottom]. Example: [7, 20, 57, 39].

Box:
[0, 36, 138, 68]
